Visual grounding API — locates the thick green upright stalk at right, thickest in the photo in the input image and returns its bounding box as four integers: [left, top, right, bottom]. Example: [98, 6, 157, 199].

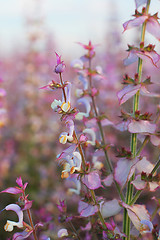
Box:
[123, 0, 151, 240]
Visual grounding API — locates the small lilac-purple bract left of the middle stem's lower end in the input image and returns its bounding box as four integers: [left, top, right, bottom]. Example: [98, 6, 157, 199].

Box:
[78, 201, 98, 217]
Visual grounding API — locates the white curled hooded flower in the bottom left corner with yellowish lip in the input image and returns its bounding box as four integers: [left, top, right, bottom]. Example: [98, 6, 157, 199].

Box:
[4, 204, 23, 232]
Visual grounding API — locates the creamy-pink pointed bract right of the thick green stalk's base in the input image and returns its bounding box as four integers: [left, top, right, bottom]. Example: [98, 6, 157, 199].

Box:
[122, 203, 150, 231]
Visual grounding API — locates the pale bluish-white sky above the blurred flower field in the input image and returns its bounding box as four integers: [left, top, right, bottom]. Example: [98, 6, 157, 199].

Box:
[0, 0, 160, 55]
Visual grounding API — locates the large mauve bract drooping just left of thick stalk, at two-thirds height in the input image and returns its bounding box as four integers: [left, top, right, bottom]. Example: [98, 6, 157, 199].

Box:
[114, 158, 135, 186]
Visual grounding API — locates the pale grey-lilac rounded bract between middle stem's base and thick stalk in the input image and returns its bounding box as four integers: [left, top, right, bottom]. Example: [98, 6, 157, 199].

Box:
[101, 199, 122, 218]
